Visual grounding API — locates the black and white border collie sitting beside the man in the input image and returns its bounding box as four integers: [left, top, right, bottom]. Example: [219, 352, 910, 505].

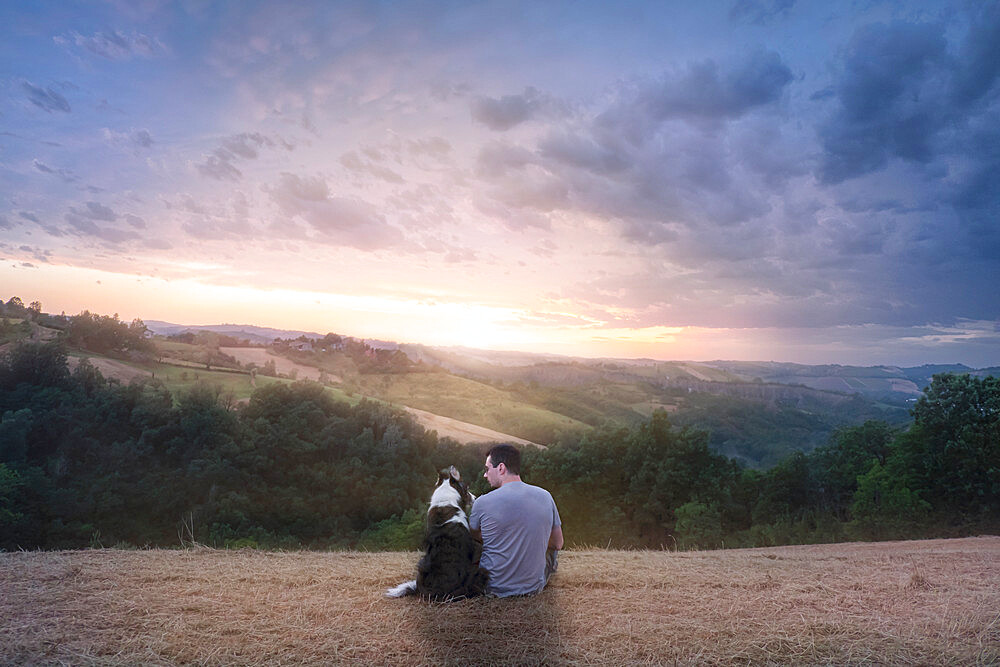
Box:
[385, 466, 489, 601]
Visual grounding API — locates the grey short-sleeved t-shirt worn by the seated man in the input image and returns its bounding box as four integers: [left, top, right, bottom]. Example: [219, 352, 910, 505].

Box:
[469, 482, 562, 597]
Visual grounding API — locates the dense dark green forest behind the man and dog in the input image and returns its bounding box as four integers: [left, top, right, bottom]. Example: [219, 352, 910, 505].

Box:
[0, 340, 1000, 550]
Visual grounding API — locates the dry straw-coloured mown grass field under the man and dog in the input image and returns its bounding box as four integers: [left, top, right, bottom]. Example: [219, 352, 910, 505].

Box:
[0, 537, 1000, 665]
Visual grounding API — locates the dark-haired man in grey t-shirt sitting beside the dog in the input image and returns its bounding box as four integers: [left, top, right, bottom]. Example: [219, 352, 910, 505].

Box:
[469, 444, 563, 597]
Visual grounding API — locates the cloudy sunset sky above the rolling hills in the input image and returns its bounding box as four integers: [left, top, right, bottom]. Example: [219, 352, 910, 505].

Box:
[0, 0, 1000, 367]
